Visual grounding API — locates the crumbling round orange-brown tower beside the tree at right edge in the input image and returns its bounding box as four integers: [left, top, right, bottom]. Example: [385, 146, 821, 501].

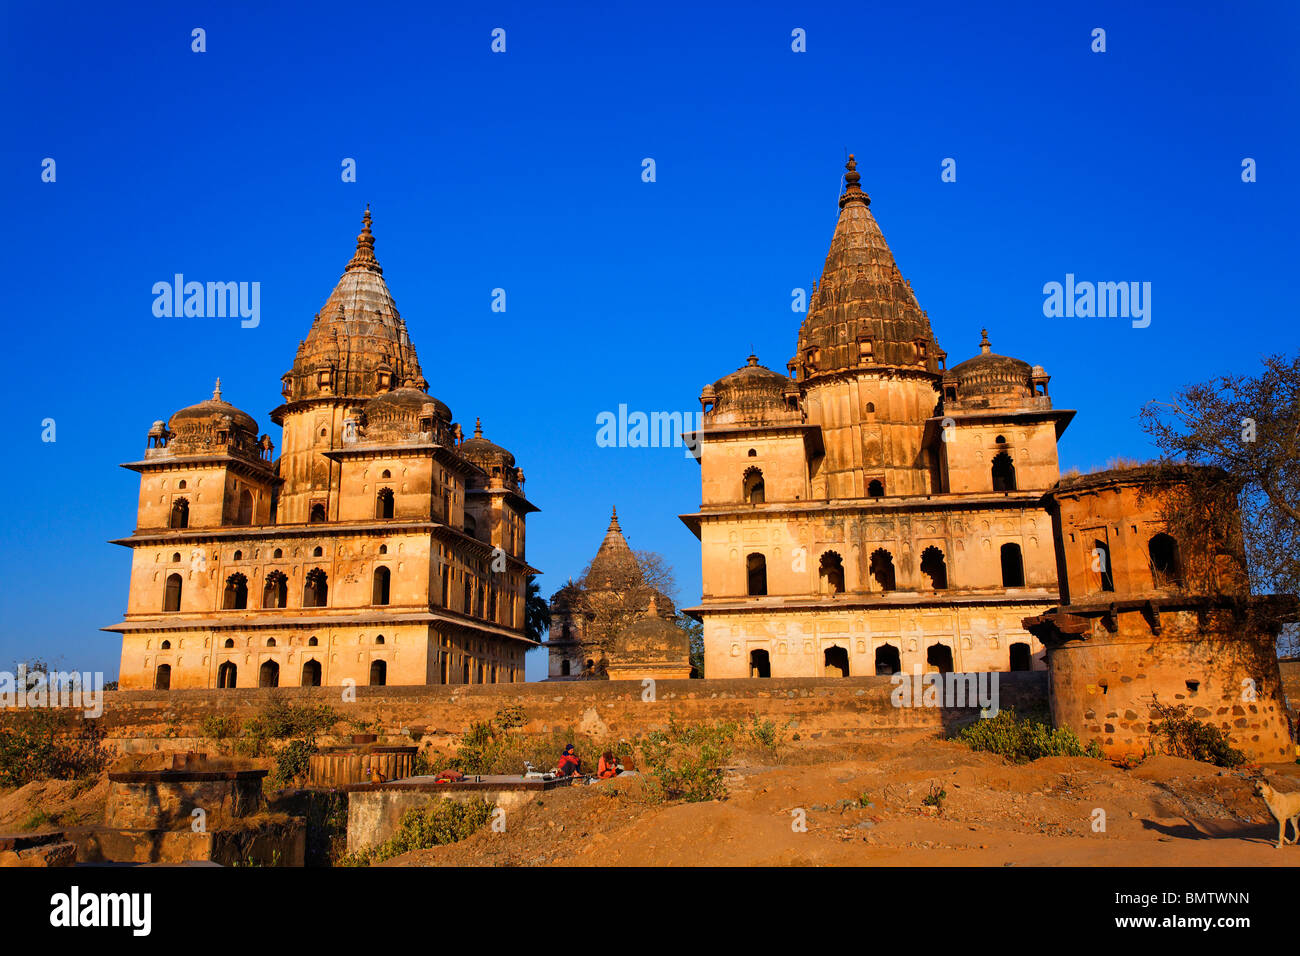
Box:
[1024, 467, 1296, 761]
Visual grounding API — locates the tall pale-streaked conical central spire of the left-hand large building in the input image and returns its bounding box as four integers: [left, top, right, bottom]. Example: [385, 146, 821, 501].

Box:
[272, 206, 428, 424]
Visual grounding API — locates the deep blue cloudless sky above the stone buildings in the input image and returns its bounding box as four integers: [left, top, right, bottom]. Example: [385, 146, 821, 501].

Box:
[0, 3, 1300, 678]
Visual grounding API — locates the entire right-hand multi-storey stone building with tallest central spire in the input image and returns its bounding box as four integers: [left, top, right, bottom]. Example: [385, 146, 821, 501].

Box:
[681, 157, 1074, 678]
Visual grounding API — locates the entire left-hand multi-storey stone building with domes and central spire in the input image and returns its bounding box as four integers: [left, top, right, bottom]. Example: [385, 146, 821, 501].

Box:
[107, 208, 537, 689]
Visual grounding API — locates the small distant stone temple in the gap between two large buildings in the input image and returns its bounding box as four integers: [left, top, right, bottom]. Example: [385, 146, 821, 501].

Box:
[546, 509, 690, 680]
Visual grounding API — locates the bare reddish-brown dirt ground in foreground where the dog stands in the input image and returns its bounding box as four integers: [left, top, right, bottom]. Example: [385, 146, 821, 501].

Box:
[384, 735, 1300, 866]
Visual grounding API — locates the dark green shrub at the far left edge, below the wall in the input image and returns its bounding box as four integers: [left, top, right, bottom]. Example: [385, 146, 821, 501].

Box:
[0, 708, 108, 787]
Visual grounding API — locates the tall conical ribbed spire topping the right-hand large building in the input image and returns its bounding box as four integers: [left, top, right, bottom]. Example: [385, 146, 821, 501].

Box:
[793, 156, 941, 376]
